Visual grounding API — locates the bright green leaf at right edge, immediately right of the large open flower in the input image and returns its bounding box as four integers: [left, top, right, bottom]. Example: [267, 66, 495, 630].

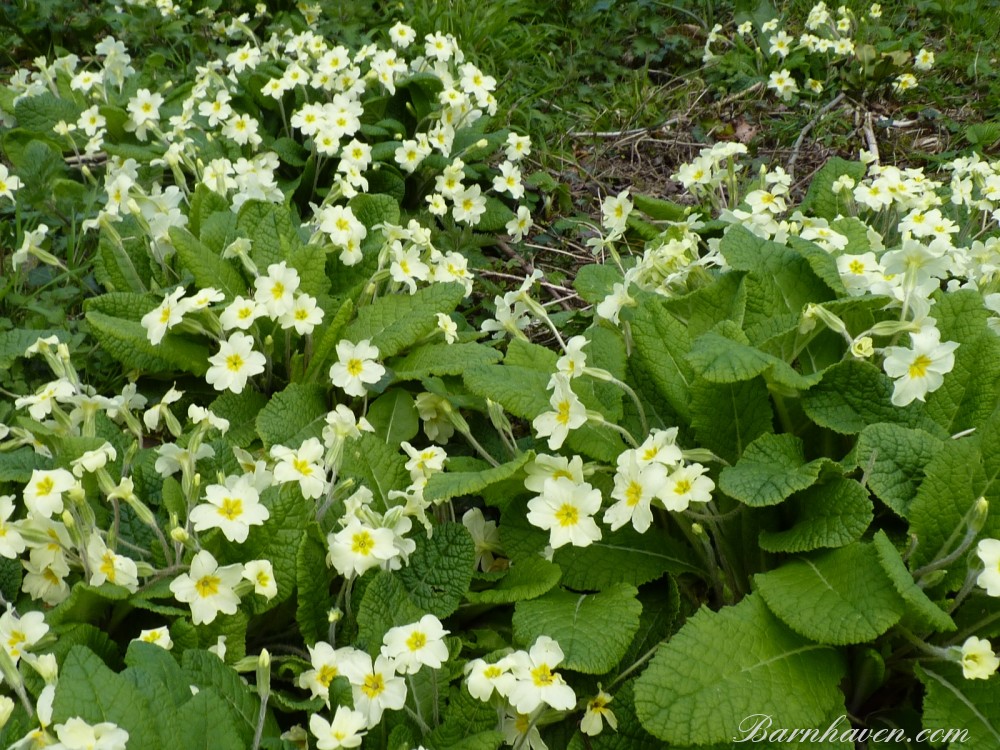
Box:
[925, 289, 1000, 434]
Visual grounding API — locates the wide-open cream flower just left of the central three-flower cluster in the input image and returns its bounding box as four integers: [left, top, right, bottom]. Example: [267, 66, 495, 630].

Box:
[527, 477, 601, 549]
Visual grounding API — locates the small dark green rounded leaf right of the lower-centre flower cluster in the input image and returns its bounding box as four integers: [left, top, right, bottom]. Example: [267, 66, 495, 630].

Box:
[397, 523, 476, 618]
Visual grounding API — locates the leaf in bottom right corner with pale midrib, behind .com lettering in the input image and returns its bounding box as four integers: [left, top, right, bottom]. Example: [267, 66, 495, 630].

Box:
[914, 662, 1000, 748]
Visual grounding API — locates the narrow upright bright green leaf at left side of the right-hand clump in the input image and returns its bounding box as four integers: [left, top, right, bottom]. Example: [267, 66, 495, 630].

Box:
[631, 294, 694, 422]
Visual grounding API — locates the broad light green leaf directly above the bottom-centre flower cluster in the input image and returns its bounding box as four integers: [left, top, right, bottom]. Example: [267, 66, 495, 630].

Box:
[513, 583, 642, 674]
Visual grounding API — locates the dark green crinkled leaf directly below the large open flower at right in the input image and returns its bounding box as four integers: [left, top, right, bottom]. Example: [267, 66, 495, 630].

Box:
[802, 358, 944, 436]
